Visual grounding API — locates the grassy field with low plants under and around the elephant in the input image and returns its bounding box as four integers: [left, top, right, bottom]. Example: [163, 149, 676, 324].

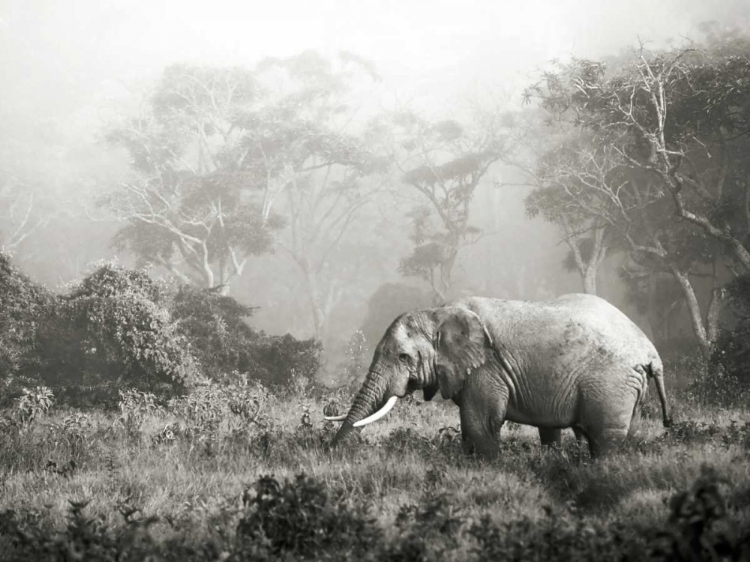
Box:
[0, 374, 750, 561]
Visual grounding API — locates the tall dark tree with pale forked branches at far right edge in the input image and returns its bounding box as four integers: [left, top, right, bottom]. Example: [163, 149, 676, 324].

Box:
[529, 28, 750, 353]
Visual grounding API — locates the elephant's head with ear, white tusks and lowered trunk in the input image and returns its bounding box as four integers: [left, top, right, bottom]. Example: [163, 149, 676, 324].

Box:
[328, 307, 492, 445]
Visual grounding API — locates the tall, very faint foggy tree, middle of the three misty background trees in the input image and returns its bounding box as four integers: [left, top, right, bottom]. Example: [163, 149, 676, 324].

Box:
[236, 51, 386, 338]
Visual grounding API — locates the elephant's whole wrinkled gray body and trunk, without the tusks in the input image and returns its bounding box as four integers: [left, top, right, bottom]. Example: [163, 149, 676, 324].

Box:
[334, 294, 669, 458]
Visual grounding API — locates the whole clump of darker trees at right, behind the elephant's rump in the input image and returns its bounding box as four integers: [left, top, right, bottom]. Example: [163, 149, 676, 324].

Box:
[525, 25, 750, 375]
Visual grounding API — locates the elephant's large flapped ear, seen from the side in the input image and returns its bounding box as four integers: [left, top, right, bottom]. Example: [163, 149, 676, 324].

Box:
[435, 308, 492, 399]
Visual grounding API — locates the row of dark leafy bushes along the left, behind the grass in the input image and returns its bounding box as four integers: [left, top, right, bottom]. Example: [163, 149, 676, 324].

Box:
[0, 253, 321, 406]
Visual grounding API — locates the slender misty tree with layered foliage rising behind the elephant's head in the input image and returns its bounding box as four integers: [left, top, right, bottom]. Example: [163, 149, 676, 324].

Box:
[374, 110, 505, 303]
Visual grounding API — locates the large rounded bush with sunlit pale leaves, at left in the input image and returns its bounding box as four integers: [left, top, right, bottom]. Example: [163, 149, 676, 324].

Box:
[41, 263, 197, 392]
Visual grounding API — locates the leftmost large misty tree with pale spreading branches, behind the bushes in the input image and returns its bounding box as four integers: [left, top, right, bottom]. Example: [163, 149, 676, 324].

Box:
[101, 65, 283, 294]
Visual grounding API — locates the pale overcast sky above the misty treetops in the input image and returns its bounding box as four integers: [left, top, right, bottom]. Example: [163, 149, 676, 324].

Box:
[0, 0, 750, 116]
